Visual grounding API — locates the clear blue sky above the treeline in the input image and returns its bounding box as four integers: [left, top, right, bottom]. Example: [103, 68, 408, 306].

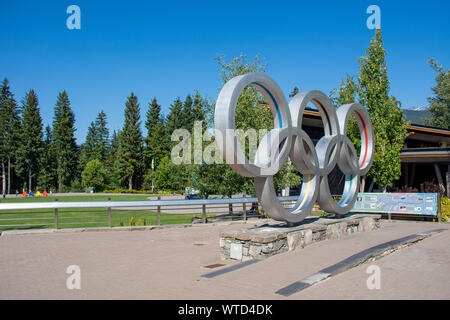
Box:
[0, 0, 450, 143]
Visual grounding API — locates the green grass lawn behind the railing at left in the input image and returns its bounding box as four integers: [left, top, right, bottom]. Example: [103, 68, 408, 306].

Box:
[0, 194, 213, 230]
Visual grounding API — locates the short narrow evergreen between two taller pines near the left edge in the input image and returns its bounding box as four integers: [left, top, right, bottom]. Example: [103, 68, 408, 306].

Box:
[38, 126, 58, 191]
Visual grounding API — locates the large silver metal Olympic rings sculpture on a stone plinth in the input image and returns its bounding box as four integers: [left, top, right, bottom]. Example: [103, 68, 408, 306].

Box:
[214, 72, 374, 223]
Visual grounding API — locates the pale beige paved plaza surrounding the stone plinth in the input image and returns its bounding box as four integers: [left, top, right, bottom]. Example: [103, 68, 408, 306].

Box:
[0, 220, 450, 299]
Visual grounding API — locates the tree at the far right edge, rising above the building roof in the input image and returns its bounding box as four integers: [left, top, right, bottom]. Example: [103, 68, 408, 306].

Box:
[425, 58, 450, 129]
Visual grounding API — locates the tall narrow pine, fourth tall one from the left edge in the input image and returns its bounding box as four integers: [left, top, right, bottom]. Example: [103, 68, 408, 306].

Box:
[119, 92, 143, 190]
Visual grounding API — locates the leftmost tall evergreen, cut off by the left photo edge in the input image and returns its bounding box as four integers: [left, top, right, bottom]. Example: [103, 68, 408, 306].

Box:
[0, 78, 20, 194]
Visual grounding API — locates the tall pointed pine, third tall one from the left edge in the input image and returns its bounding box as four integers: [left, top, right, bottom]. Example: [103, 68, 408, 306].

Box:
[53, 90, 78, 192]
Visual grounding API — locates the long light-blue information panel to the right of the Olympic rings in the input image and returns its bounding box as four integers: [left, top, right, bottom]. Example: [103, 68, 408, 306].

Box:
[350, 192, 437, 215]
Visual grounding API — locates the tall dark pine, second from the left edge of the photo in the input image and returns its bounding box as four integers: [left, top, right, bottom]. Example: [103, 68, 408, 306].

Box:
[16, 90, 44, 191]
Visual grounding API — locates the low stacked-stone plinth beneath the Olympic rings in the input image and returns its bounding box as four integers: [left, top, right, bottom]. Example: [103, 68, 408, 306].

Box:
[220, 214, 381, 261]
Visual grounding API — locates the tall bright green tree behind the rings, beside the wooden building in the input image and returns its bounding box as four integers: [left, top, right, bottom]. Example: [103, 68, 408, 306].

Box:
[358, 29, 407, 190]
